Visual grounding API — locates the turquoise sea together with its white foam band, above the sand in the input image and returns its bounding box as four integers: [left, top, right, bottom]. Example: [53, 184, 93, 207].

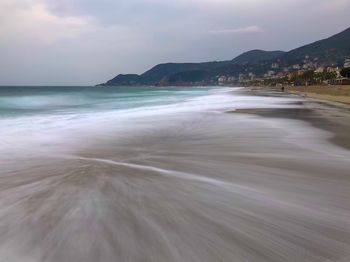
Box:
[0, 86, 298, 157]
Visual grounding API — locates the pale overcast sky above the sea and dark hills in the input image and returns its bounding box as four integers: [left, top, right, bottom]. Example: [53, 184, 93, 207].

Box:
[0, 0, 350, 85]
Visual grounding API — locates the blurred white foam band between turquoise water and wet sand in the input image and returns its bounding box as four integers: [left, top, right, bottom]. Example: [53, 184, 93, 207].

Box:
[0, 88, 295, 158]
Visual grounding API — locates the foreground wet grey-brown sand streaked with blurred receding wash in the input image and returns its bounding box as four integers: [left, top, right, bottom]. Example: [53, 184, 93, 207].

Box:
[0, 89, 350, 262]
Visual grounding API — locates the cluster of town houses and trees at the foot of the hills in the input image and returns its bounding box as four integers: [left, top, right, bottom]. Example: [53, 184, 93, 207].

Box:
[217, 56, 350, 86]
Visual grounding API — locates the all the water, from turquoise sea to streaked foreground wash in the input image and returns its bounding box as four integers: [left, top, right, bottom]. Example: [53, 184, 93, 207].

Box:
[0, 88, 350, 262]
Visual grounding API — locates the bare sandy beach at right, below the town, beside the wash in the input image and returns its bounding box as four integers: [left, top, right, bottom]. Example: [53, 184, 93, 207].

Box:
[238, 86, 350, 149]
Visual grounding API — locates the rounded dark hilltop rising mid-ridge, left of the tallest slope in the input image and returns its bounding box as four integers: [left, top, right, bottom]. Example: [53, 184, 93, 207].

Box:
[232, 50, 285, 64]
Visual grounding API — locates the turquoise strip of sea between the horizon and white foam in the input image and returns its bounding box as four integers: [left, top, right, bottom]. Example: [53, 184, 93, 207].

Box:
[0, 86, 213, 118]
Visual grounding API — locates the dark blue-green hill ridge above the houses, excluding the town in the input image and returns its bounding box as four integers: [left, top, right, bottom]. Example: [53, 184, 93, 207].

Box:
[102, 28, 350, 86]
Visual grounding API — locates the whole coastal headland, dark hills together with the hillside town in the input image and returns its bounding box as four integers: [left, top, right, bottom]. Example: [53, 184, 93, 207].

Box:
[101, 28, 350, 86]
